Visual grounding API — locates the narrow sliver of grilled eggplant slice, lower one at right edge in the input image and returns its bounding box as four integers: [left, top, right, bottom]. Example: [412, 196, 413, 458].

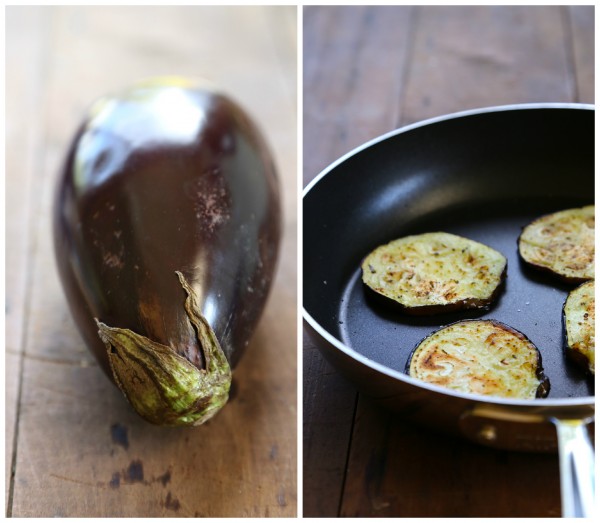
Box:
[563, 280, 596, 374]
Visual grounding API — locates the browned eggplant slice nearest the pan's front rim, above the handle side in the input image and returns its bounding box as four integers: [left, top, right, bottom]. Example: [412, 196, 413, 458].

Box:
[408, 320, 550, 399]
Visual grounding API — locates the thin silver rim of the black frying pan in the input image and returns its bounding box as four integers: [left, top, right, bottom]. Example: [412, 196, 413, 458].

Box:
[302, 102, 595, 408]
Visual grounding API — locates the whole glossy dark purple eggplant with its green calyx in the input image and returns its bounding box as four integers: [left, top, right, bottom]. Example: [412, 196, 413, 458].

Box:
[53, 77, 281, 425]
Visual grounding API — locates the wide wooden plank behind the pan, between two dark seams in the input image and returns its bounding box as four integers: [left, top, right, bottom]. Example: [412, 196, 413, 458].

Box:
[401, 6, 574, 124]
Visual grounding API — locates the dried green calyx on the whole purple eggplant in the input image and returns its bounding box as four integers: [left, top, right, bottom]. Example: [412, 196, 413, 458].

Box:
[96, 272, 231, 425]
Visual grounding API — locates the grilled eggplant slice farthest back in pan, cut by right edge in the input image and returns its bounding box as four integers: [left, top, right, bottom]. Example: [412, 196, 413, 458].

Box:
[519, 205, 595, 283]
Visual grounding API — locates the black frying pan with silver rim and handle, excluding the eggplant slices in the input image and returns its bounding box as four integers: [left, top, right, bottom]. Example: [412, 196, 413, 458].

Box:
[303, 104, 594, 516]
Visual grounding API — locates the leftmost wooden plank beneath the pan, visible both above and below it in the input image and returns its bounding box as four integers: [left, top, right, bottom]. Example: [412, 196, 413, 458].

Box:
[303, 7, 412, 517]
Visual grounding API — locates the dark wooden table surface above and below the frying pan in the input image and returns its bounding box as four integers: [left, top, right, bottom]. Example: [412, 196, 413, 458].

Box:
[303, 6, 594, 517]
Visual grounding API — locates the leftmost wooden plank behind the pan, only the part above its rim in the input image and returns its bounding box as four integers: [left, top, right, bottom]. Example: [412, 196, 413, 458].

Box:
[303, 6, 413, 184]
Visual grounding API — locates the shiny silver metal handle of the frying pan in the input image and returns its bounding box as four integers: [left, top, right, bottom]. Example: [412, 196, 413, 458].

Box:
[551, 417, 596, 518]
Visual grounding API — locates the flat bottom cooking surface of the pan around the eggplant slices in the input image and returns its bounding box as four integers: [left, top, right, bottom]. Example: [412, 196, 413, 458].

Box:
[338, 202, 594, 401]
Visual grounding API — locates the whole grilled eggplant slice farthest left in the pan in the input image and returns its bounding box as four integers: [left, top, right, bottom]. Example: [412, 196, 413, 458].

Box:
[362, 232, 507, 314]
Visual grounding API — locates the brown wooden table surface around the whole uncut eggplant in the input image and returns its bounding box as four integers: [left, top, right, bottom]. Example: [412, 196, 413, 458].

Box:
[5, 7, 297, 517]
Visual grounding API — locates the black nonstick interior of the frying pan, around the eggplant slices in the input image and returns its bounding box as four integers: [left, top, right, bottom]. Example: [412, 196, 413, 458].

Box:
[303, 108, 594, 398]
